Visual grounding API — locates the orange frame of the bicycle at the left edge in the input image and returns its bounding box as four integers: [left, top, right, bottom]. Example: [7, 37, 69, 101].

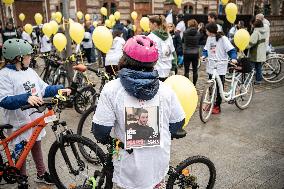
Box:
[0, 109, 55, 175]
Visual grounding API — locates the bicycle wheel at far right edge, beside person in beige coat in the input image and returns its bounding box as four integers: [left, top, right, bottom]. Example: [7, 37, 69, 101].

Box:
[262, 57, 284, 83]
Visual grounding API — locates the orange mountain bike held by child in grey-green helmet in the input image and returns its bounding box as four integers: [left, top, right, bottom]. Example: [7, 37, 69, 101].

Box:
[0, 94, 102, 189]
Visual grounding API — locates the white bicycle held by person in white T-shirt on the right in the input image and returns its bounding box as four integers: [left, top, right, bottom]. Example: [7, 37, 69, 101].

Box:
[199, 59, 255, 123]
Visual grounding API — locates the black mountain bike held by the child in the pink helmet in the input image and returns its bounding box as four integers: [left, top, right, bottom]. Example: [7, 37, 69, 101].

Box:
[51, 134, 216, 189]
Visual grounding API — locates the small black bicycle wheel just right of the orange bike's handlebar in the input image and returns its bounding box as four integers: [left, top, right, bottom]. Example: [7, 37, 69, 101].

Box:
[74, 86, 96, 114]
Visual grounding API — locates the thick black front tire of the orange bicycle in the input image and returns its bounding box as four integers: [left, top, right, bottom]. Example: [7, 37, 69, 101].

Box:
[48, 134, 106, 189]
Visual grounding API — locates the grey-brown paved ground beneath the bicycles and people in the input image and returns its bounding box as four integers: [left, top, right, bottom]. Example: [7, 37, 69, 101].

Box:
[0, 58, 284, 189]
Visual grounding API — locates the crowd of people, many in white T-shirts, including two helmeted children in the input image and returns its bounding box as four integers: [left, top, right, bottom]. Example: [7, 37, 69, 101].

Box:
[0, 10, 270, 189]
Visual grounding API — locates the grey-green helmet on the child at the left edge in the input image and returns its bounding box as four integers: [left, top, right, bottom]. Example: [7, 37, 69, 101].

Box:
[2, 39, 33, 60]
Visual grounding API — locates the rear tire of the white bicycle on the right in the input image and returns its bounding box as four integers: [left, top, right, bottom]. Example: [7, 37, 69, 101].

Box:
[235, 77, 254, 110]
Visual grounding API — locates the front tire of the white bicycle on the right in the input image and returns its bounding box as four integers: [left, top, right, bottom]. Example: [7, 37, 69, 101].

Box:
[199, 82, 217, 123]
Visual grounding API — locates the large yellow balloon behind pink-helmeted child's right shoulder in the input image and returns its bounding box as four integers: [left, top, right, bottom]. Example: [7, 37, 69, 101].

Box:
[165, 75, 198, 127]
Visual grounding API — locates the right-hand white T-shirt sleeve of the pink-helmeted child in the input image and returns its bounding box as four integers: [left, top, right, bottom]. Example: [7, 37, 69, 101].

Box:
[170, 92, 185, 123]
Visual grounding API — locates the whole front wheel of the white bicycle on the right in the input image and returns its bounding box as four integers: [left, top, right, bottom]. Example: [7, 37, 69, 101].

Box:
[199, 82, 216, 123]
